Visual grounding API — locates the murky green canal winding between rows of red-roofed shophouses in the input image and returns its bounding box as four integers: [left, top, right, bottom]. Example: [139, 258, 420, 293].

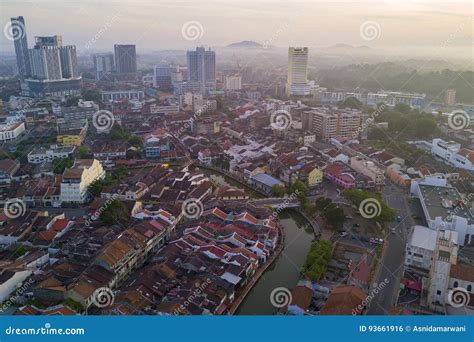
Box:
[202, 170, 314, 315]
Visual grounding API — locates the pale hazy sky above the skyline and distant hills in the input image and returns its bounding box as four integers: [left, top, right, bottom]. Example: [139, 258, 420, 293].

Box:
[0, 0, 474, 53]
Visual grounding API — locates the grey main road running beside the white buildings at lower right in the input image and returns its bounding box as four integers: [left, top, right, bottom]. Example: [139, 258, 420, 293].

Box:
[367, 183, 415, 315]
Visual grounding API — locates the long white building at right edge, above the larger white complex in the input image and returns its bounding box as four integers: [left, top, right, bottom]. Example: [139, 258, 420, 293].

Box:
[431, 139, 474, 171]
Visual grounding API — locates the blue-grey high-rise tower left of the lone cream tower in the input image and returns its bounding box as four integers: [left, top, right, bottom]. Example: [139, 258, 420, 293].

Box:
[187, 47, 216, 92]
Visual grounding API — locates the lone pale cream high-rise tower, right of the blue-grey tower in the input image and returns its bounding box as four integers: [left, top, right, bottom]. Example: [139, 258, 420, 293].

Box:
[286, 47, 311, 95]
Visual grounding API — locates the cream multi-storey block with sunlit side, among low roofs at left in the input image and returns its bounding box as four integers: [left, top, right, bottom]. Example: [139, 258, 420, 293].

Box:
[61, 159, 105, 203]
